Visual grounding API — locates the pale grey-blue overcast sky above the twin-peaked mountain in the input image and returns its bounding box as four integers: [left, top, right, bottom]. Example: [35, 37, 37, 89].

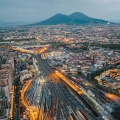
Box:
[0, 0, 120, 22]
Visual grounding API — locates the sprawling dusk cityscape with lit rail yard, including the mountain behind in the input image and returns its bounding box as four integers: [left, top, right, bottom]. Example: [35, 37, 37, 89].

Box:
[0, 0, 120, 120]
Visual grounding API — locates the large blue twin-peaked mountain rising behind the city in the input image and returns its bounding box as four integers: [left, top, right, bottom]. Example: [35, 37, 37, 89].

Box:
[32, 12, 108, 25]
